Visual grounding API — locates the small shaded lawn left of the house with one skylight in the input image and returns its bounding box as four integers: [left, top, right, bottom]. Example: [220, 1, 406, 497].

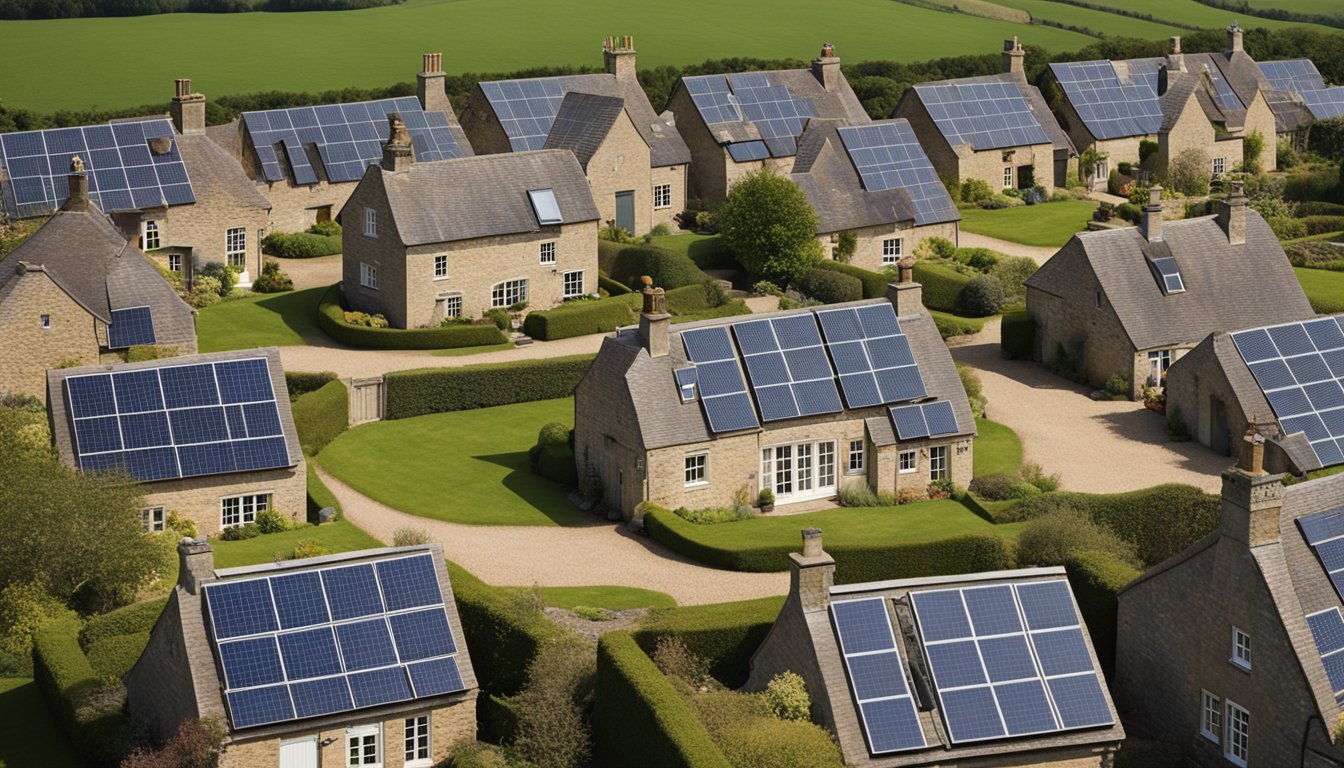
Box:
[196, 288, 327, 352]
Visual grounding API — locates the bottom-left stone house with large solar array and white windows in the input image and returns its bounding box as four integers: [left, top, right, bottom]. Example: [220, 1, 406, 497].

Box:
[124, 538, 477, 768]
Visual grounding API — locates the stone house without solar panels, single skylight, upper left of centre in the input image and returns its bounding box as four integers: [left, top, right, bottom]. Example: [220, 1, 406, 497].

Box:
[340, 121, 598, 328]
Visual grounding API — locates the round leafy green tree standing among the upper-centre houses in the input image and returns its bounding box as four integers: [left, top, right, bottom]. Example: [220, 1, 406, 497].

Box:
[715, 168, 821, 284]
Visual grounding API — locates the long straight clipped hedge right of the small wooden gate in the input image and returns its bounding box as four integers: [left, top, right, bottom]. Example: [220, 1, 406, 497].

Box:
[386, 355, 595, 418]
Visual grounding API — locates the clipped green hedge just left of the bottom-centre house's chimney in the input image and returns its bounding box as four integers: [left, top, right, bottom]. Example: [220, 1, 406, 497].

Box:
[632, 597, 784, 689]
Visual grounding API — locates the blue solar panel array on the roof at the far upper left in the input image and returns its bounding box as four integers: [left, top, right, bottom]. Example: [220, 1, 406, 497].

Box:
[0, 120, 196, 218]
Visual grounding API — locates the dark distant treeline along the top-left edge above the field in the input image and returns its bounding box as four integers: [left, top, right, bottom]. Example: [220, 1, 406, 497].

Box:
[0, 0, 403, 19]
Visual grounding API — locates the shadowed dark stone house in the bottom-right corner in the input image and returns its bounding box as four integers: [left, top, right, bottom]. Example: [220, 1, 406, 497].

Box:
[1114, 436, 1344, 768]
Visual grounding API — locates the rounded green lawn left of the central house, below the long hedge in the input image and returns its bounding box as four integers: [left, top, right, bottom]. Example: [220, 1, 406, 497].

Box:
[317, 398, 593, 526]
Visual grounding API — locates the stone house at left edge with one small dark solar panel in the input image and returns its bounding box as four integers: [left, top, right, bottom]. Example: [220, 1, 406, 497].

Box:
[0, 169, 196, 397]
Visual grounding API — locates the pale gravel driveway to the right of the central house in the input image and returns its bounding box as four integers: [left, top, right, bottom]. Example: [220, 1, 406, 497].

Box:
[952, 319, 1231, 494]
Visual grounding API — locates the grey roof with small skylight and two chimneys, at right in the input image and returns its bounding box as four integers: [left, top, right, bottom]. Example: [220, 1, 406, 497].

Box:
[1027, 208, 1314, 350]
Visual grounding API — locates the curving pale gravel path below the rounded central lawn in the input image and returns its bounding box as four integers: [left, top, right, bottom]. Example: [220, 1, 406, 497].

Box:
[317, 468, 784, 605]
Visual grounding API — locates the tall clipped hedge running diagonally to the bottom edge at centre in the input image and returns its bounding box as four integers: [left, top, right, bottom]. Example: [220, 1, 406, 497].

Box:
[593, 632, 730, 768]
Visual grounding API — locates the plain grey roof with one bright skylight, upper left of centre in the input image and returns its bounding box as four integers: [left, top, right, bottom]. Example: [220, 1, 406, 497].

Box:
[360, 149, 598, 246]
